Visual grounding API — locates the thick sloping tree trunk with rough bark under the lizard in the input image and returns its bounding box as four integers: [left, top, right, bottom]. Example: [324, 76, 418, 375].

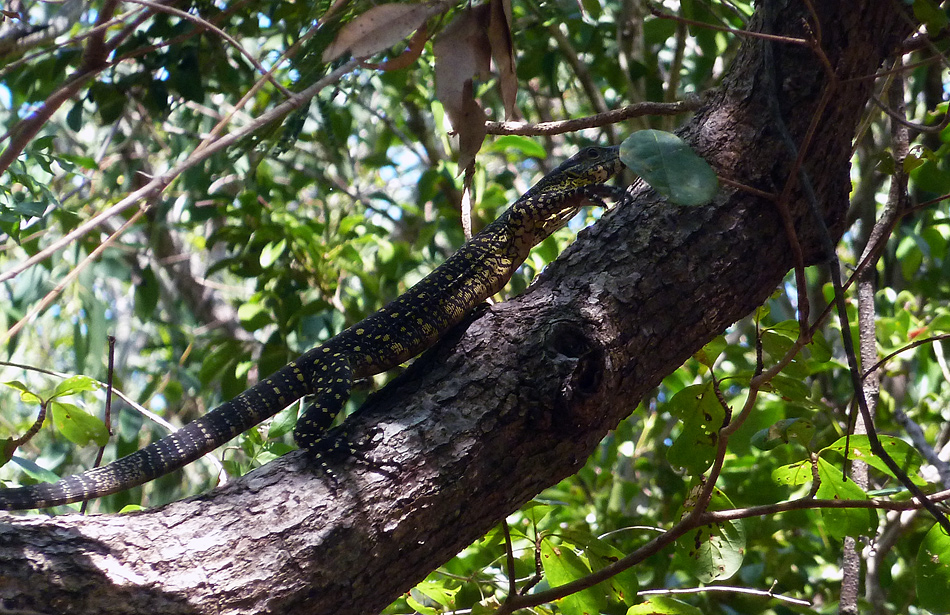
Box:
[0, 0, 914, 614]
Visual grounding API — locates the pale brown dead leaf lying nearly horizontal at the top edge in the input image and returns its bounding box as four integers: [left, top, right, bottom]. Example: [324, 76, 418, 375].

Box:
[323, 2, 450, 62]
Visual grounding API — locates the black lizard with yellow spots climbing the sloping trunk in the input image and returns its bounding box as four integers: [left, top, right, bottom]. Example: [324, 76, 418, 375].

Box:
[0, 147, 621, 510]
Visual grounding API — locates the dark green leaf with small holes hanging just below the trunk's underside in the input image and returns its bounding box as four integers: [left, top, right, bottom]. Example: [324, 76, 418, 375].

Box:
[666, 383, 725, 476]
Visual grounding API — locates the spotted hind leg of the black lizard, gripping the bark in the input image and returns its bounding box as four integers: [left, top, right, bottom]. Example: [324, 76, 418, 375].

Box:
[294, 354, 353, 458]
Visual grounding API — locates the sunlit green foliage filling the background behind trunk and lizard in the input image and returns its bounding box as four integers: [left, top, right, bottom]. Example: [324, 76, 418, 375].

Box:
[0, 0, 950, 613]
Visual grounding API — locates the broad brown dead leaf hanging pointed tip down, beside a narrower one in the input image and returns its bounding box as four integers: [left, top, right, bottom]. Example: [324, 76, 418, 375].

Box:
[433, 4, 491, 170]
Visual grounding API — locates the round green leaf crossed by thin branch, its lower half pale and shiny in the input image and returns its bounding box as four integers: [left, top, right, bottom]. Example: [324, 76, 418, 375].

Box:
[676, 482, 746, 583]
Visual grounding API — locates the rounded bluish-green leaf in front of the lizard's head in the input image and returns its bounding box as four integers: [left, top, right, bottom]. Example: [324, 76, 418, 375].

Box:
[620, 130, 719, 206]
